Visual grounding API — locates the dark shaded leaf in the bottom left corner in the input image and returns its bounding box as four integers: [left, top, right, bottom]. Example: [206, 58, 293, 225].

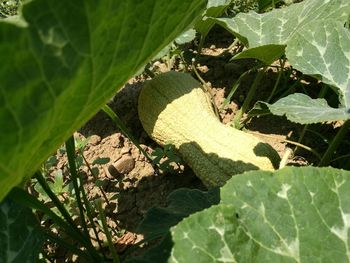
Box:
[0, 198, 44, 263]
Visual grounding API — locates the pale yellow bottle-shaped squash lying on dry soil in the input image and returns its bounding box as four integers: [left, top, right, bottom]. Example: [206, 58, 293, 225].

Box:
[138, 72, 279, 187]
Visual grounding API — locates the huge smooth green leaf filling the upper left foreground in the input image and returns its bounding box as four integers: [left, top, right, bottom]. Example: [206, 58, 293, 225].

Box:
[0, 0, 205, 200]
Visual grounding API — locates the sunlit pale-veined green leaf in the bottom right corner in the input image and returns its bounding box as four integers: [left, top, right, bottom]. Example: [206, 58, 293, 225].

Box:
[171, 167, 350, 263]
